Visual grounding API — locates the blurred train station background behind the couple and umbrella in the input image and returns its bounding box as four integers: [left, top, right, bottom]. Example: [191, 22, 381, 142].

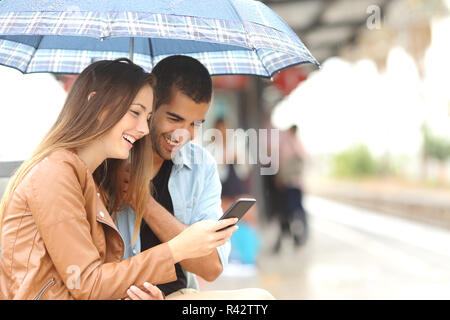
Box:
[0, 0, 450, 299]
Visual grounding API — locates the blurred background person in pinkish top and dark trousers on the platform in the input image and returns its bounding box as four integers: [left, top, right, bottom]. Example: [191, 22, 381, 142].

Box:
[273, 125, 308, 253]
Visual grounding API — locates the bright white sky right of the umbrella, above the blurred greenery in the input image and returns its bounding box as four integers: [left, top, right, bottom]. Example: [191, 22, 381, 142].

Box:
[272, 18, 450, 159]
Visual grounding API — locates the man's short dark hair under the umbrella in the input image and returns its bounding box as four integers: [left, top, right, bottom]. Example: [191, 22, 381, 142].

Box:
[152, 55, 212, 109]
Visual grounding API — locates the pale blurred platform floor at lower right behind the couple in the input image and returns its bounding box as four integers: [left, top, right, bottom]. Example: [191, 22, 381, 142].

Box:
[200, 196, 450, 300]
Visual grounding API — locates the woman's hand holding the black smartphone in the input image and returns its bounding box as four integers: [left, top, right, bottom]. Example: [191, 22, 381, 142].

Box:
[168, 218, 238, 262]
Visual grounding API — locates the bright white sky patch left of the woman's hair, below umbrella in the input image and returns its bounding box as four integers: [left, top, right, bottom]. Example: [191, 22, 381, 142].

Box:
[0, 66, 66, 161]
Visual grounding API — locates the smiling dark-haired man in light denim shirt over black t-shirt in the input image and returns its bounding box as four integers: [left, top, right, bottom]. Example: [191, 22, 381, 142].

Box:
[117, 56, 230, 295]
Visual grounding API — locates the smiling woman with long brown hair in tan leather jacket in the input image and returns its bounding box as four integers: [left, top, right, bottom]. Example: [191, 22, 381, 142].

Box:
[0, 59, 237, 299]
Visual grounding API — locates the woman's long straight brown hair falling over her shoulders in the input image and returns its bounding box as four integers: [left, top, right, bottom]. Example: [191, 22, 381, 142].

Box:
[0, 58, 155, 242]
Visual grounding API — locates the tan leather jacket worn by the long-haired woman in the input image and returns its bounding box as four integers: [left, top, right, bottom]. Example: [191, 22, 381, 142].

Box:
[0, 150, 176, 299]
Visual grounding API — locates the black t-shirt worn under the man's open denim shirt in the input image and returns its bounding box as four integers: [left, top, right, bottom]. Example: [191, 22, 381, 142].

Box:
[141, 160, 187, 295]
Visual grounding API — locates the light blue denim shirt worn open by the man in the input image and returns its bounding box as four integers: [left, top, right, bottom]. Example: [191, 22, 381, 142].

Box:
[116, 142, 231, 289]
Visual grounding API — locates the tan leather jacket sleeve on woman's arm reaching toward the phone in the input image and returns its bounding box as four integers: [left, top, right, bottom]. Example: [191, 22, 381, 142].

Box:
[29, 161, 176, 299]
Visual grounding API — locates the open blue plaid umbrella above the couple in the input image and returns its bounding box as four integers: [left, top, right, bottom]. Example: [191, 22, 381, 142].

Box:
[0, 0, 319, 77]
